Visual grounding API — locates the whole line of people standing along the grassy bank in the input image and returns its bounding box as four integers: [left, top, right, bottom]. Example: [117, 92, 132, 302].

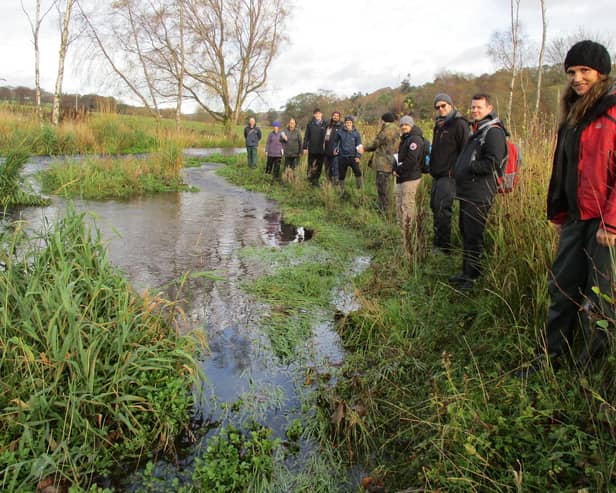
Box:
[245, 40, 616, 375]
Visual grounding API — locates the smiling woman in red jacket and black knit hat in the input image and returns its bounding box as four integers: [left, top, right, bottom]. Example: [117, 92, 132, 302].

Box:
[527, 41, 616, 373]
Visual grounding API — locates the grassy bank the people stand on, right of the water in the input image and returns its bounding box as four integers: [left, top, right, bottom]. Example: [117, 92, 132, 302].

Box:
[209, 129, 616, 492]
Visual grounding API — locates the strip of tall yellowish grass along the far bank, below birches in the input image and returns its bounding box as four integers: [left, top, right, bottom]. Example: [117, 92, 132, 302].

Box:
[0, 106, 243, 156]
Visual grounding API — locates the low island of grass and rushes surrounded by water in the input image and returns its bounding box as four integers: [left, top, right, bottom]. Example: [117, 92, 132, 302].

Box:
[40, 144, 188, 200]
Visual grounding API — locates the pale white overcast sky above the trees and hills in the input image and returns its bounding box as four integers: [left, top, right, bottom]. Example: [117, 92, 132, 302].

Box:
[0, 0, 616, 111]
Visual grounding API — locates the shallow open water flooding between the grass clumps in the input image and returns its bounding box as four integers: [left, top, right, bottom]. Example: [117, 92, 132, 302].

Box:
[9, 149, 367, 491]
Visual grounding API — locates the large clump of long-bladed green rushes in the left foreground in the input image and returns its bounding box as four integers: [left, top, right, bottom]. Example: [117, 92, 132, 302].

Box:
[0, 210, 201, 492]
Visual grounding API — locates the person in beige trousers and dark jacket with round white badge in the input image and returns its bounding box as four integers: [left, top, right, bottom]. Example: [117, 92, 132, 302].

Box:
[394, 116, 425, 244]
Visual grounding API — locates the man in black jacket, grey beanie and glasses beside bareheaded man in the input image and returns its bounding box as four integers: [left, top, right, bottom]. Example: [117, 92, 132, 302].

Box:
[430, 93, 469, 253]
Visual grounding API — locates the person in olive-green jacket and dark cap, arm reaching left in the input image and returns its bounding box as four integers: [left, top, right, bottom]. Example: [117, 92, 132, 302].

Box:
[364, 112, 400, 213]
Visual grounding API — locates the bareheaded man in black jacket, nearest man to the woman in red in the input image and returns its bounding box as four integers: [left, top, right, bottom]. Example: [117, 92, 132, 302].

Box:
[449, 94, 507, 290]
